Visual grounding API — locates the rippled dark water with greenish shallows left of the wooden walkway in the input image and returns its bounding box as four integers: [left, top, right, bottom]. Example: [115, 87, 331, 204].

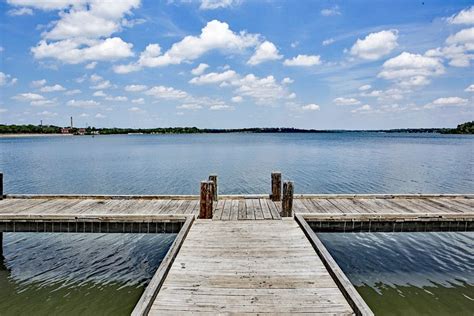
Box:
[0, 233, 176, 315]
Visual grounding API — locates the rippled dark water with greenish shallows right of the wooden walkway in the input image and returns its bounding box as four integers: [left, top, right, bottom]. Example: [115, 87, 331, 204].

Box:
[318, 232, 474, 315]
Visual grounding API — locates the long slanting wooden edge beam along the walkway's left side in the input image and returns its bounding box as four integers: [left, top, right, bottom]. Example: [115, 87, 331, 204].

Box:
[132, 216, 194, 316]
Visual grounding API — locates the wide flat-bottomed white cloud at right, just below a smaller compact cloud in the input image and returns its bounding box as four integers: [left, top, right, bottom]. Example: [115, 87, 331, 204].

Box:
[378, 52, 445, 87]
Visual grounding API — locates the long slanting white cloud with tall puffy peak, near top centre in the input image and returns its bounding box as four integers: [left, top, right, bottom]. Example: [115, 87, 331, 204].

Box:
[114, 20, 259, 73]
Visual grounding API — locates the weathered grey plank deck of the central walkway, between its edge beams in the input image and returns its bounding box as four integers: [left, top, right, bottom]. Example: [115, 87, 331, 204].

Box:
[150, 218, 353, 315]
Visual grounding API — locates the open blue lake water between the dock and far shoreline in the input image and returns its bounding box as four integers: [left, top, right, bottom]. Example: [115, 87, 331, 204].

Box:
[0, 133, 474, 194]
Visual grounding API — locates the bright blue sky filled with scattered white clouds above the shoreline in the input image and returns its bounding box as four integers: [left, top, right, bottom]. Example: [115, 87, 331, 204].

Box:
[0, 0, 474, 129]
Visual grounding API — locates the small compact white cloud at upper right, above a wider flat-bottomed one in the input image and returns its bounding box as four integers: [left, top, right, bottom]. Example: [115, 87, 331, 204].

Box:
[350, 30, 398, 60]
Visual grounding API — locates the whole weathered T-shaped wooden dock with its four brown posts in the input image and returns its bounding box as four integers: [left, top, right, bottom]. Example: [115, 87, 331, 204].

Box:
[0, 174, 474, 315]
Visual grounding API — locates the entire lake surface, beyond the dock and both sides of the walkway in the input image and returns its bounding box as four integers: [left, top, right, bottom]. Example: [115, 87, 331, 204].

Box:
[0, 133, 474, 315]
